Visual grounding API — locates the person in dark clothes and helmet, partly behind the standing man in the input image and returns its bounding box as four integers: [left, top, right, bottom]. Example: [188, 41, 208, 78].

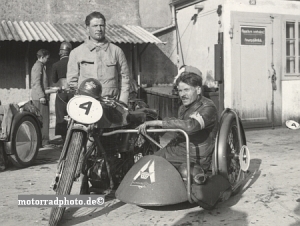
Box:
[52, 42, 74, 141]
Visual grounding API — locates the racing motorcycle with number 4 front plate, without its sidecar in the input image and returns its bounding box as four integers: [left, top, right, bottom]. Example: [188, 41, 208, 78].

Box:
[49, 91, 159, 225]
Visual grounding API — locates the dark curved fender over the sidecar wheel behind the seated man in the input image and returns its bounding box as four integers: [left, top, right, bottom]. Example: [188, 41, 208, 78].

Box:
[214, 108, 246, 178]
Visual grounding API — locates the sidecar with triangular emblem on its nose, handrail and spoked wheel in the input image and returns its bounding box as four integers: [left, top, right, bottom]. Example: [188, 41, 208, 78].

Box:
[116, 109, 250, 209]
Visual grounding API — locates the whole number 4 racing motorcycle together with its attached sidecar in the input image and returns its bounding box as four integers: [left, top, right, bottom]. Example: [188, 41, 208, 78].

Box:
[49, 80, 250, 225]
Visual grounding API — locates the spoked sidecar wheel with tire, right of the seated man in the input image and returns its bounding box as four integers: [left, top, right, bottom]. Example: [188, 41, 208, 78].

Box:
[217, 113, 246, 195]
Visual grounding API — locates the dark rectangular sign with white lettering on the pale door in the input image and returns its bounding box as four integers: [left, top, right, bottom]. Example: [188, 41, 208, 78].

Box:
[241, 27, 266, 45]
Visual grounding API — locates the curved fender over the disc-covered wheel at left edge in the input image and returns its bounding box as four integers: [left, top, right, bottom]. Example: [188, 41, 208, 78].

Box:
[3, 111, 42, 155]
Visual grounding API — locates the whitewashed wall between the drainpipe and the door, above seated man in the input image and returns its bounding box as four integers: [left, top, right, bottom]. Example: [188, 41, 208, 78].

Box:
[177, 1, 220, 86]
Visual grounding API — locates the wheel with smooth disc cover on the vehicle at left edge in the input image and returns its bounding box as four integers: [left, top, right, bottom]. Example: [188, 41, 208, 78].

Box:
[9, 116, 42, 168]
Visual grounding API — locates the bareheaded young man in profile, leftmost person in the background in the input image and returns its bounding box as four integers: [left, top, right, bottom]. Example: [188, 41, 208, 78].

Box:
[31, 49, 50, 145]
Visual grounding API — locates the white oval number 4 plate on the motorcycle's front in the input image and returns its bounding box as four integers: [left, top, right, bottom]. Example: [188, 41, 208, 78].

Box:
[67, 96, 103, 124]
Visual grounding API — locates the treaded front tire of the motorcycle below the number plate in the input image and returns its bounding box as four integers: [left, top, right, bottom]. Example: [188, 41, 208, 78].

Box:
[49, 131, 84, 226]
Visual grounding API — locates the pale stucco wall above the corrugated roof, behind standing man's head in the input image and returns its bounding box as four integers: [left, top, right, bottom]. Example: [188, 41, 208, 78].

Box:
[0, 0, 140, 25]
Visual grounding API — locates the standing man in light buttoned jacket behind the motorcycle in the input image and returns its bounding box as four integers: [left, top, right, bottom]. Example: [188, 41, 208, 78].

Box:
[67, 12, 130, 104]
